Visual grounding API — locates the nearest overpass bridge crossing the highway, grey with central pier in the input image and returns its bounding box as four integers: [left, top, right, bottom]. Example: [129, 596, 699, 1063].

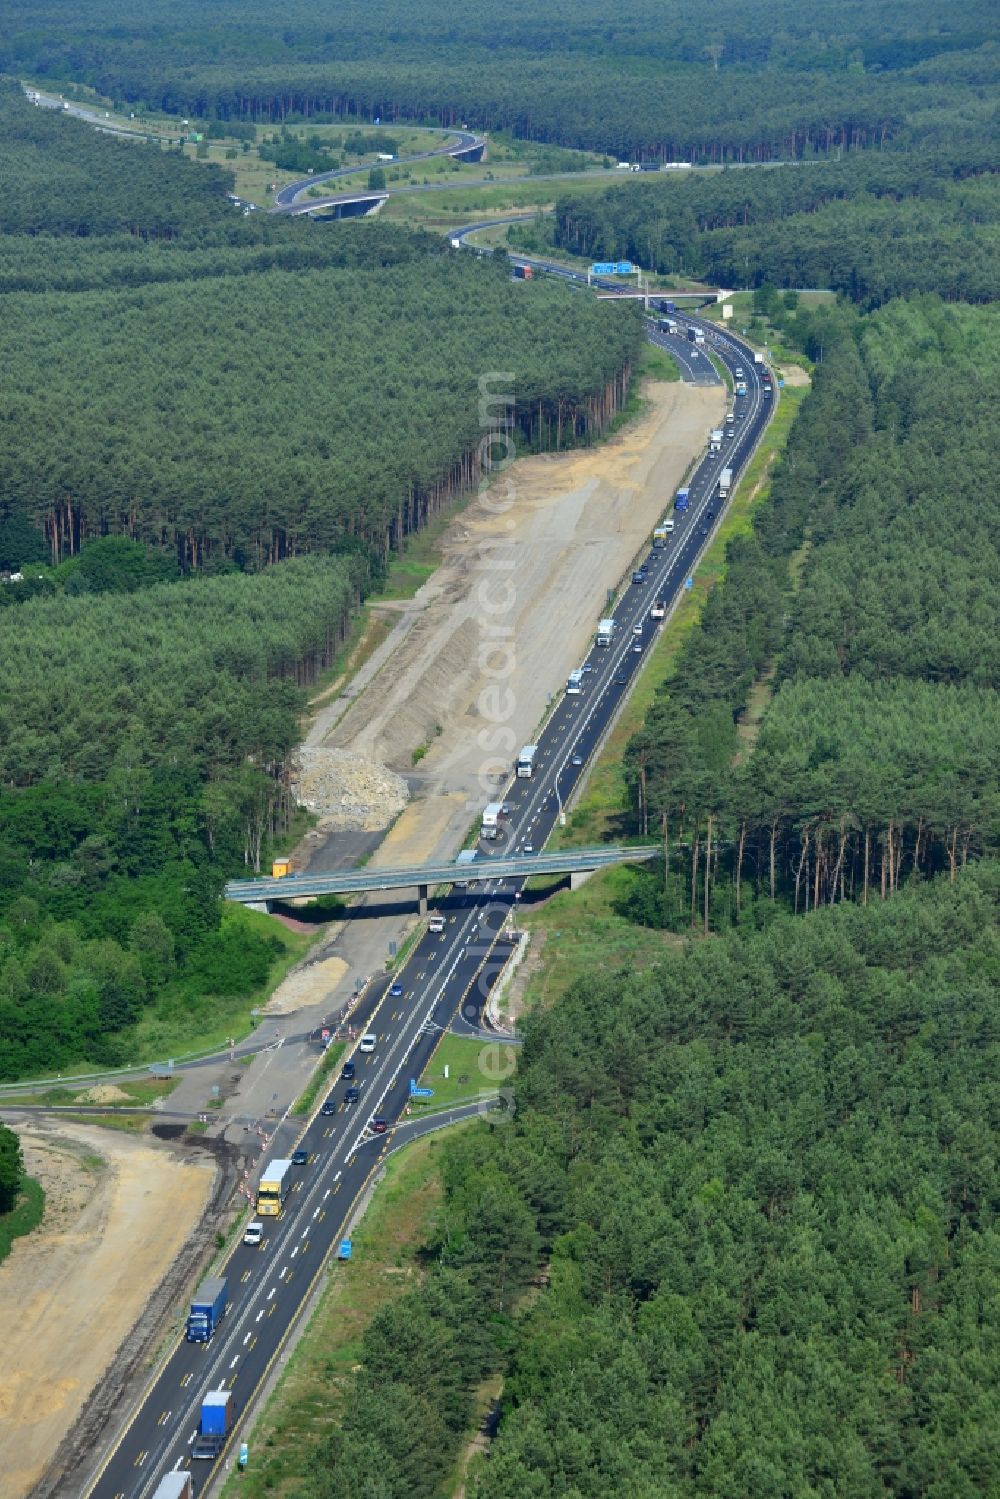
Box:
[225, 844, 660, 916]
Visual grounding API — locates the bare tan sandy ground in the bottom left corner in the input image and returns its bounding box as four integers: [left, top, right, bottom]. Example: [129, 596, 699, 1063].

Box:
[0, 1121, 213, 1499]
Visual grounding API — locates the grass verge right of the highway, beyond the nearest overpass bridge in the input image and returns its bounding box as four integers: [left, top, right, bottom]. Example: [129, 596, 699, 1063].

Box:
[550, 387, 807, 848]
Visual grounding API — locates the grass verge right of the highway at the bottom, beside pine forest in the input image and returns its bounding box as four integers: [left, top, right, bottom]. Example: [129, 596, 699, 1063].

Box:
[223, 1136, 464, 1499]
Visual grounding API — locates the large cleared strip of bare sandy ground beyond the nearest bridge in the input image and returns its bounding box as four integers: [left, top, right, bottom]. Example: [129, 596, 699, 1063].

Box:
[309, 381, 726, 865]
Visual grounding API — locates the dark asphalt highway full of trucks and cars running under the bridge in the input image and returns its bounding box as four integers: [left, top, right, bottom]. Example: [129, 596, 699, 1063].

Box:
[81, 315, 777, 1499]
